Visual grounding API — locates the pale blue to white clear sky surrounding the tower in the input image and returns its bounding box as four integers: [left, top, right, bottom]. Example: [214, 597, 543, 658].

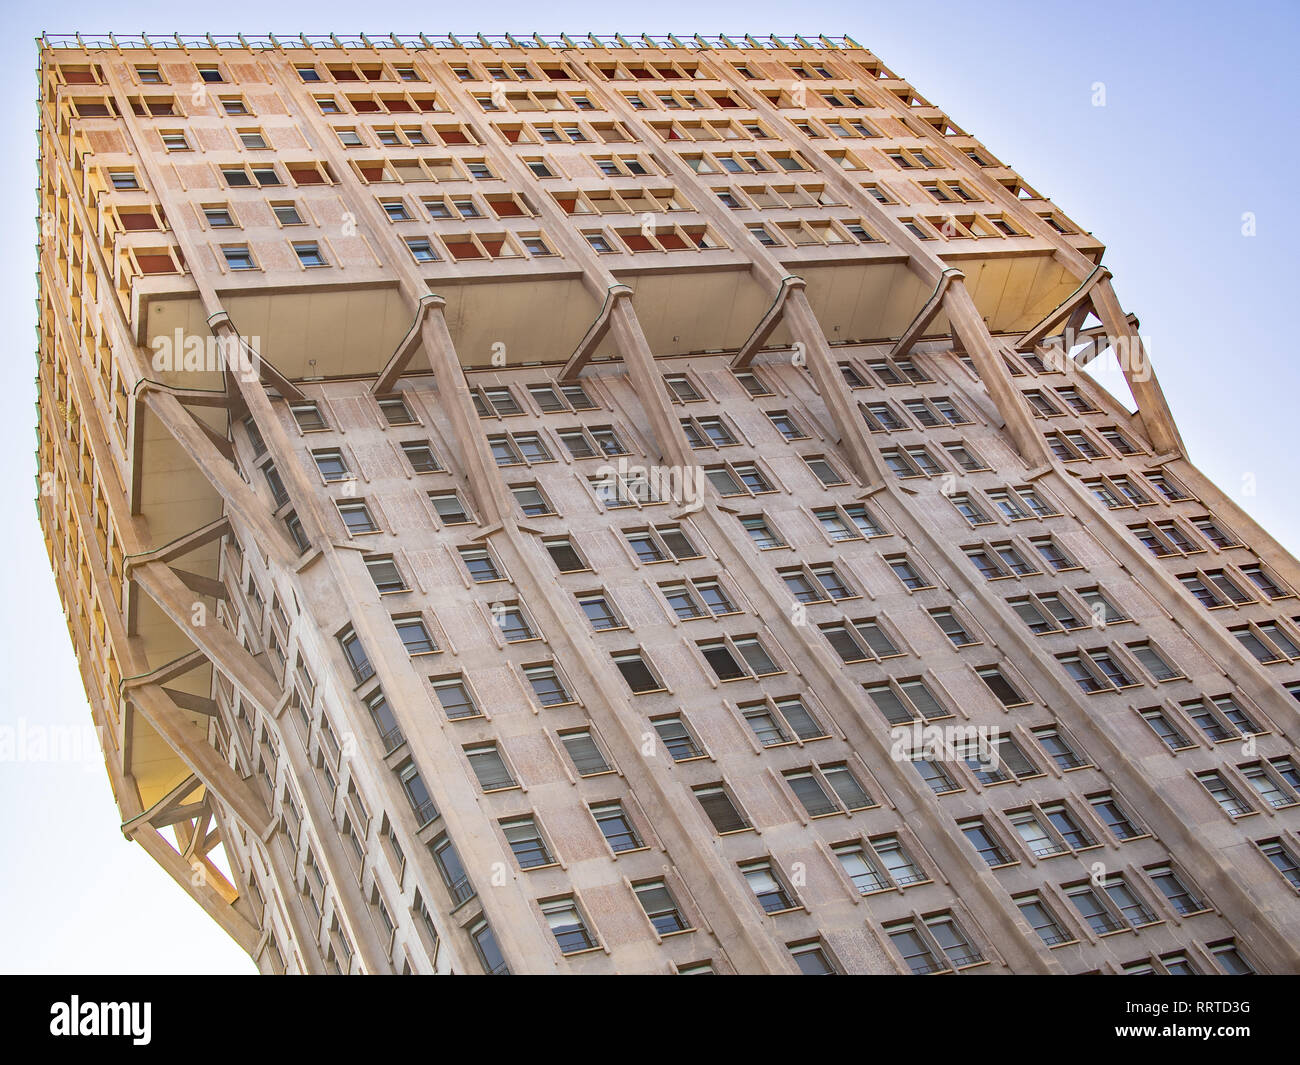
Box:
[0, 0, 1300, 973]
